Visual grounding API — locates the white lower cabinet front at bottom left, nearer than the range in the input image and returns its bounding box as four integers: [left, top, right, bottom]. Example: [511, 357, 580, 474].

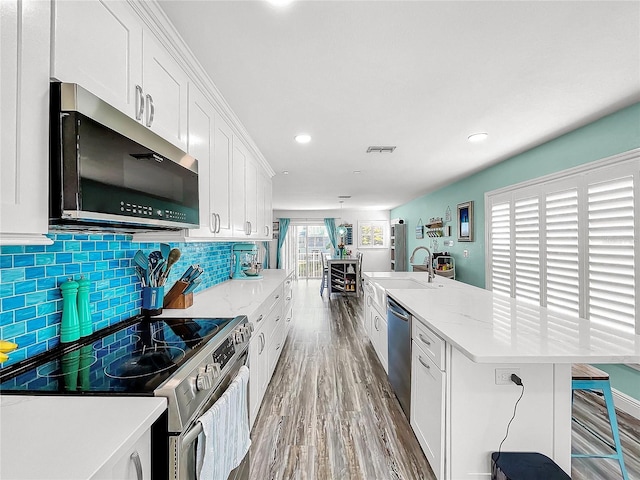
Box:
[93, 429, 151, 480]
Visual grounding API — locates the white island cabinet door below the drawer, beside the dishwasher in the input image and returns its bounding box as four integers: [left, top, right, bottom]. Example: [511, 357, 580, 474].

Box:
[411, 341, 446, 479]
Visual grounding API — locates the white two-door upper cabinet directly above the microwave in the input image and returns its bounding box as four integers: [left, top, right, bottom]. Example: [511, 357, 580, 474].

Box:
[51, 0, 188, 149]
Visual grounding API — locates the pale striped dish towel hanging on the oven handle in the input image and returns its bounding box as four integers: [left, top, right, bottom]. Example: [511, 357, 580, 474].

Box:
[196, 365, 251, 480]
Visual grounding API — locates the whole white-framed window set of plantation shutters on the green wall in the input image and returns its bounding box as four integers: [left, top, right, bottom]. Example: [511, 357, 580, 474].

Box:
[485, 151, 640, 334]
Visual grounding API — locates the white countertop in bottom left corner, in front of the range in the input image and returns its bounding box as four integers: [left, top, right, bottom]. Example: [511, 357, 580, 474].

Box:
[0, 395, 167, 480]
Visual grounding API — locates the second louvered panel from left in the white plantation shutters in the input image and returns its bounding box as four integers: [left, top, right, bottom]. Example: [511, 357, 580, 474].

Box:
[513, 197, 540, 303]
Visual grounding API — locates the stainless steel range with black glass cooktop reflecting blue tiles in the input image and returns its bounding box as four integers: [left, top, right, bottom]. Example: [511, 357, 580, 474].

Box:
[0, 316, 252, 480]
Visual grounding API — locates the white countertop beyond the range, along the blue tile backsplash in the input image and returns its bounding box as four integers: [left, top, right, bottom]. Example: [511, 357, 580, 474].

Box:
[158, 269, 290, 318]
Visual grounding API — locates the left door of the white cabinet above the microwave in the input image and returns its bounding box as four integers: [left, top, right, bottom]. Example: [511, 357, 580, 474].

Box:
[51, 0, 144, 120]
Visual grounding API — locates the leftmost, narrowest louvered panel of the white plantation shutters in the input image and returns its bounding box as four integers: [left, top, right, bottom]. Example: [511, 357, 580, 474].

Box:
[489, 202, 511, 295]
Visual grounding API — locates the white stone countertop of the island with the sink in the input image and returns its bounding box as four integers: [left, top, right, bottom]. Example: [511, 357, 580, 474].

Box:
[364, 272, 640, 363]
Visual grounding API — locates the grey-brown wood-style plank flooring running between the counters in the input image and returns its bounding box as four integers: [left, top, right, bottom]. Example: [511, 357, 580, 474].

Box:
[250, 280, 640, 480]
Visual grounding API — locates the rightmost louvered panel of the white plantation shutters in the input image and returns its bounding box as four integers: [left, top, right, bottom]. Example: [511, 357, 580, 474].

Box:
[587, 176, 636, 331]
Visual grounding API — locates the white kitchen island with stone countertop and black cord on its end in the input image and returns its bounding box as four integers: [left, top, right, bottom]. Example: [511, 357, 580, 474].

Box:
[365, 272, 640, 480]
